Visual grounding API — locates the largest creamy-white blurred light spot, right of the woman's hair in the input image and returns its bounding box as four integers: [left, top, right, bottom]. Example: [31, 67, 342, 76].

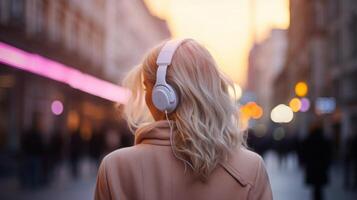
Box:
[270, 104, 294, 123]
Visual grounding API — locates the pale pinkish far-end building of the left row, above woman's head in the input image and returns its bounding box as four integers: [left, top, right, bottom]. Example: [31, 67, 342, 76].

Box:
[106, 0, 171, 80]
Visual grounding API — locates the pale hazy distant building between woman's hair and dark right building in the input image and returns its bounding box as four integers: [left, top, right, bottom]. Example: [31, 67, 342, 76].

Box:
[246, 29, 287, 123]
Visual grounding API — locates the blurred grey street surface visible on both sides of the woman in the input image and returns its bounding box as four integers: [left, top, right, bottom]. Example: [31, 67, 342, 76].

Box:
[0, 152, 357, 200]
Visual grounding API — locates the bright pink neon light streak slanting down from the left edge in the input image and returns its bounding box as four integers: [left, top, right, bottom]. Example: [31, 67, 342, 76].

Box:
[0, 42, 131, 104]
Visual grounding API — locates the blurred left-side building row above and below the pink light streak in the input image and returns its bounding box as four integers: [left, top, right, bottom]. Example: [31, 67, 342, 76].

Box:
[0, 0, 170, 154]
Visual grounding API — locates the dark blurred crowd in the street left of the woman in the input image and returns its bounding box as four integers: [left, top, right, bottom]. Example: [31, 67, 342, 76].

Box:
[18, 121, 134, 189]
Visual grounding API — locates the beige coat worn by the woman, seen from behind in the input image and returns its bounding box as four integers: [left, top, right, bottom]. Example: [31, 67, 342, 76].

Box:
[95, 121, 272, 200]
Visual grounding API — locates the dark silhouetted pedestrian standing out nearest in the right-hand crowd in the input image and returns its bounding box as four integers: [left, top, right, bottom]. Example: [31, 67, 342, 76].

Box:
[301, 122, 332, 200]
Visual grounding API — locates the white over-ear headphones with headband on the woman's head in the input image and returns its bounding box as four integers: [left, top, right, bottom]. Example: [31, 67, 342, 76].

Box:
[152, 39, 187, 113]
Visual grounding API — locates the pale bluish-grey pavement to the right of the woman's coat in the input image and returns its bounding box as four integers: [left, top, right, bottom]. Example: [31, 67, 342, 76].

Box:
[264, 152, 357, 200]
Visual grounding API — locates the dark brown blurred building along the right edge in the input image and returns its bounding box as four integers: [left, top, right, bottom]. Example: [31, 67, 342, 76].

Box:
[274, 0, 357, 152]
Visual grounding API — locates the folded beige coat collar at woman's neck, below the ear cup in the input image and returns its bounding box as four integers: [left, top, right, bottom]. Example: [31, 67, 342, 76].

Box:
[135, 120, 174, 146]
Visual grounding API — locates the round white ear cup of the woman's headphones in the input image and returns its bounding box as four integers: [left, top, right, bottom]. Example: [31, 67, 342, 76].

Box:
[152, 84, 178, 113]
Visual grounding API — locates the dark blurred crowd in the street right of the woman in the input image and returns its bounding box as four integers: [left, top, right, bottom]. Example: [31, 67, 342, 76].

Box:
[248, 120, 357, 200]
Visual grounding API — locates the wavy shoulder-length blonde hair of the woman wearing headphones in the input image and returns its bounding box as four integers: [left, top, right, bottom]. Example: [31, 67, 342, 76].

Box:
[123, 40, 245, 179]
